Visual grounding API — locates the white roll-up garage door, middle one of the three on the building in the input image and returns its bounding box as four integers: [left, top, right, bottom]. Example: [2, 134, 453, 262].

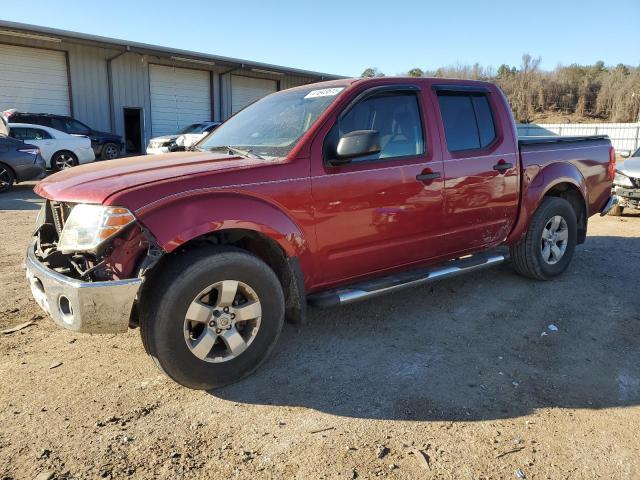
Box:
[149, 65, 211, 137]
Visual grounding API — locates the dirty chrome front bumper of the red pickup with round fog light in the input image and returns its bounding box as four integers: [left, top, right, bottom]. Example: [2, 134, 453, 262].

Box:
[25, 243, 143, 333]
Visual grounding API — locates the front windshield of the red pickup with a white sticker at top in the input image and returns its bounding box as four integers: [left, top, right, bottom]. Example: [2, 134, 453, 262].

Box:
[198, 87, 345, 157]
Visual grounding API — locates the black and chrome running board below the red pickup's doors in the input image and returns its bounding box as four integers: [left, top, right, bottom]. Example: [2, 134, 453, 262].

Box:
[307, 253, 507, 308]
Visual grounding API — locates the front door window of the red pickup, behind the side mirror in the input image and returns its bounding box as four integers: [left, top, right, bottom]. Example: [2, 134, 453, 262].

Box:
[325, 92, 425, 163]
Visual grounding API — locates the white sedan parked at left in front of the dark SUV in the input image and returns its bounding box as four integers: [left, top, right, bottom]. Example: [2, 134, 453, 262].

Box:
[9, 123, 96, 170]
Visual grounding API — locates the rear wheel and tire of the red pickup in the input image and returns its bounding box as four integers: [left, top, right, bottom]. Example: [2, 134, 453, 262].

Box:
[509, 197, 578, 280]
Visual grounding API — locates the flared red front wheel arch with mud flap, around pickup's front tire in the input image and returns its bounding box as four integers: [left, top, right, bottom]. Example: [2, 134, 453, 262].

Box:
[139, 193, 311, 323]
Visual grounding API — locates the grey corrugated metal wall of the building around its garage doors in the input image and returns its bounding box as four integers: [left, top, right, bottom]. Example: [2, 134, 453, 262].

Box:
[0, 34, 324, 144]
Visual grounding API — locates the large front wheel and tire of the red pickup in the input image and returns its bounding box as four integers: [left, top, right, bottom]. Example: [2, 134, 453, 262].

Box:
[140, 247, 284, 390]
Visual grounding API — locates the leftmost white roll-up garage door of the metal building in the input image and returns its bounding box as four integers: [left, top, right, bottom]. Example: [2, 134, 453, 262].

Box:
[0, 44, 71, 115]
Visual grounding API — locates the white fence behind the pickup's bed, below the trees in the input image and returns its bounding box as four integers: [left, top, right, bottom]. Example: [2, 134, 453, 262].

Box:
[517, 122, 640, 152]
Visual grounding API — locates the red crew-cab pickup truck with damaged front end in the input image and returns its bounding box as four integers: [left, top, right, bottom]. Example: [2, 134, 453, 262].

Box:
[26, 78, 615, 389]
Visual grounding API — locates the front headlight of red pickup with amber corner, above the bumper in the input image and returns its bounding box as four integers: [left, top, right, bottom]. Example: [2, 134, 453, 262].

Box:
[58, 203, 135, 253]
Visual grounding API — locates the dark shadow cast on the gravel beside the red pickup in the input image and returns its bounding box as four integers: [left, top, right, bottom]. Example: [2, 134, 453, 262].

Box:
[211, 235, 640, 420]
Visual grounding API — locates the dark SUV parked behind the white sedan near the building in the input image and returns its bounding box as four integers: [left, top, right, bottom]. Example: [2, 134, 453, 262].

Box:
[4, 110, 124, 160]
